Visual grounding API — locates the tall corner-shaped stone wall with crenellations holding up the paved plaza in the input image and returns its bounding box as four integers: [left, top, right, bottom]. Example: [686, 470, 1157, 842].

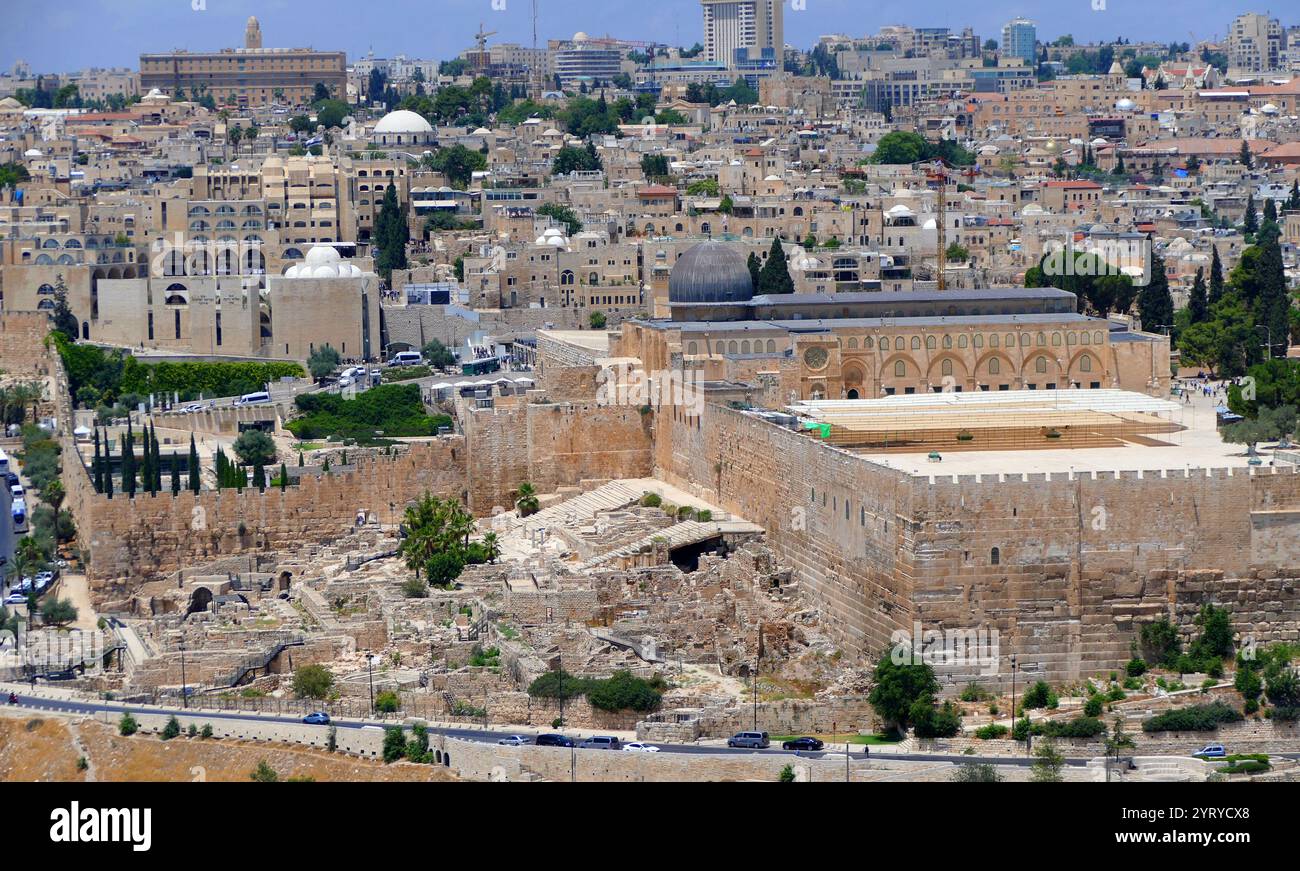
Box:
[655, 404, 1300, 685]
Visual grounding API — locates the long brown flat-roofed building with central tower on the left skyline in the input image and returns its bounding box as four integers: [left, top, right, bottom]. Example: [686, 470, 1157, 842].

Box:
[140, 18, 347, 107]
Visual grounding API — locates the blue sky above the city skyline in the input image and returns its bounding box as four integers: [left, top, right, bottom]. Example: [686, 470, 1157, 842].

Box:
[0, 0, 1258, 73]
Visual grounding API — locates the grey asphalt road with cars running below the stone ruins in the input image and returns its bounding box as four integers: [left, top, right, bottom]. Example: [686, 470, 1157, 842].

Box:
[5, 694, 1088, 767]
